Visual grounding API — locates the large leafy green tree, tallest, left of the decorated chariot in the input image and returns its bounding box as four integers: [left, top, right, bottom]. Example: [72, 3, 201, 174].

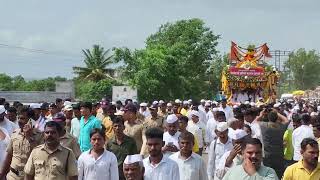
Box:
[115, 19, 219, 100]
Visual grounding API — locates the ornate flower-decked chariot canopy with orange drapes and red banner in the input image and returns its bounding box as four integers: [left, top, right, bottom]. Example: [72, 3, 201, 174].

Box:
[221, 42, 279, 101]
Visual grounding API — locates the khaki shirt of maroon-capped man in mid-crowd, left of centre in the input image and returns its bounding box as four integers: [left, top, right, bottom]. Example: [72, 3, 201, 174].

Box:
[123, 120, 143, 152]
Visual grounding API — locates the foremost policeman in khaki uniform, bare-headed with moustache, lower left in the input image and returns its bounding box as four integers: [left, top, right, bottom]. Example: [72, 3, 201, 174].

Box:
[24, 121, 78, 180]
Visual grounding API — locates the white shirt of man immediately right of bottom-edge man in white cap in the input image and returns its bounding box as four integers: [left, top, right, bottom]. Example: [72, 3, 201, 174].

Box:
[143, 156, 180, 180]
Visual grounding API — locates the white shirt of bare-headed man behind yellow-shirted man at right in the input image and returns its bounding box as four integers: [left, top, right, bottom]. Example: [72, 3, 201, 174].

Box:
[292, 125, 314, 161]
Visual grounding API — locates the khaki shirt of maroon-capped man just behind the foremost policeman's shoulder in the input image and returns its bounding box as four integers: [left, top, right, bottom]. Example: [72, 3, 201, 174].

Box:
[60, 132, 81, 159]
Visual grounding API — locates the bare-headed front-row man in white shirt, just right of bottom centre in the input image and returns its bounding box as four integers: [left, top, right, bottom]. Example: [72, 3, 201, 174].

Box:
[170, 132, 208, 180]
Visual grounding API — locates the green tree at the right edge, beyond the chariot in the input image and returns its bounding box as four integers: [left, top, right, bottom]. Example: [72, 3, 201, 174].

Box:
[285, 49, 320, 90]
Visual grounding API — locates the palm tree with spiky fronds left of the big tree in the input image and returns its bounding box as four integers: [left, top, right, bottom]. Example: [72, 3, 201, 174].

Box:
[73, 45, 114, 82]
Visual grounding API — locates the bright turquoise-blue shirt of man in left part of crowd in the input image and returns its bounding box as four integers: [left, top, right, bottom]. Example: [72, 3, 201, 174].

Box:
[79, 116, 101, 152]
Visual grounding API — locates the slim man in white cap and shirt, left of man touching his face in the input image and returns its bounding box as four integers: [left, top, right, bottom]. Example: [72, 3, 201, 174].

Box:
[207, 122, 233, 180]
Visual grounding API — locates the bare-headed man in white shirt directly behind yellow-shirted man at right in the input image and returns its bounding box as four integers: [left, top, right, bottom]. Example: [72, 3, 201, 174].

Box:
[292, 114, 314, 161]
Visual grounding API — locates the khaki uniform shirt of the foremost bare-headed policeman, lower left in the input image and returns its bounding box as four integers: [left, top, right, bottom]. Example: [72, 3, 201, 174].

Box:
[24, 144, 78, 180]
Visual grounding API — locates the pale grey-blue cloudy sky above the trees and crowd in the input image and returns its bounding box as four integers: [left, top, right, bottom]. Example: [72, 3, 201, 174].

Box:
[0, 0, 320, 78]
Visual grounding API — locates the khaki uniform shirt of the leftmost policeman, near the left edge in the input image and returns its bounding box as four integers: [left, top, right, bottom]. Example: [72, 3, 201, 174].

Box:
[7, 129, 43, 180]
